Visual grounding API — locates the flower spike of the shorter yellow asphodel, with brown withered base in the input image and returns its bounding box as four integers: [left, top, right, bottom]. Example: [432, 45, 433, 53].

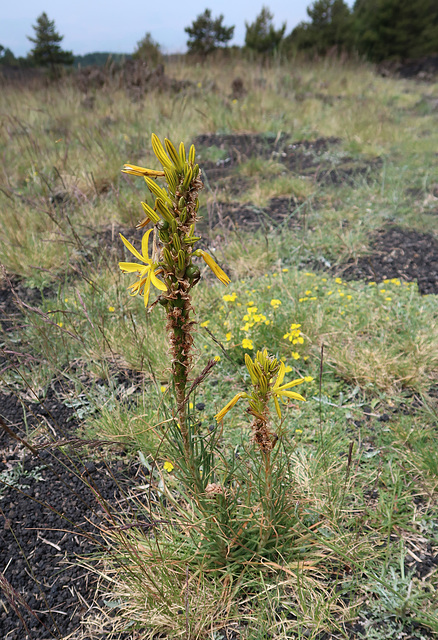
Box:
[215, 349, 305, 453]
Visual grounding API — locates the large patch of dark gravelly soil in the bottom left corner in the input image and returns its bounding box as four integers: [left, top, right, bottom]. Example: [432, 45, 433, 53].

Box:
[0, 389, 146, 640]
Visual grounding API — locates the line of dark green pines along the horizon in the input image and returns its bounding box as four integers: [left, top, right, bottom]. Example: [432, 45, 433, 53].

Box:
[0, 0, 438, 71]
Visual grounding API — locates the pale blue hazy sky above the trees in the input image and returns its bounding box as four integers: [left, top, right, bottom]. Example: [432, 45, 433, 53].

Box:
[0, 0, 334, 56]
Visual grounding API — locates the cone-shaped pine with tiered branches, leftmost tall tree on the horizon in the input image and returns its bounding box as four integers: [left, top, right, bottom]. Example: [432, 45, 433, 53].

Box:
[27, 12, 73, 72]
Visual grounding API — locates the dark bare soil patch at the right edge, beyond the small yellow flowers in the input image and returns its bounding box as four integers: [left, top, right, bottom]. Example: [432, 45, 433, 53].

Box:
[336, 227, 438, 295]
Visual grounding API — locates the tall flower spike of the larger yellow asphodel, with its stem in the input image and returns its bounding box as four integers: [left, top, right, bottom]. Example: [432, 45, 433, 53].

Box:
[119, 134, 230, 458]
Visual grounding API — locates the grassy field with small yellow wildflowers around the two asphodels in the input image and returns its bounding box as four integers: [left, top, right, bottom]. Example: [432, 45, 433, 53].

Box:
[0, 60, 438, 640]
